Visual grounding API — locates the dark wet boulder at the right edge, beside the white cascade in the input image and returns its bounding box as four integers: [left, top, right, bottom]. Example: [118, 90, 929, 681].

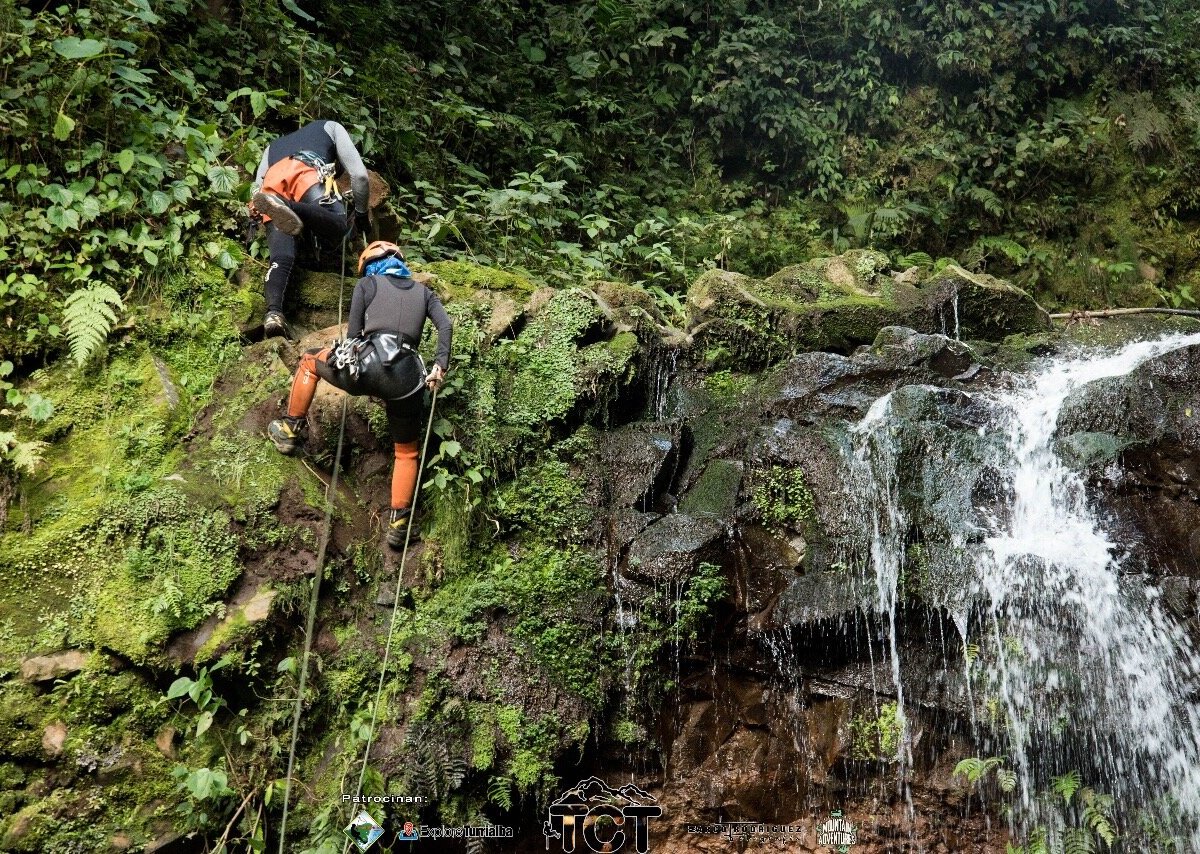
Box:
[1058, 345, 1200, 578]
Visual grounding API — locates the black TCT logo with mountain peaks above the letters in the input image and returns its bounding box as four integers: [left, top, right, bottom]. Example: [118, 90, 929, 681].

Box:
[541, 777, 662, 854]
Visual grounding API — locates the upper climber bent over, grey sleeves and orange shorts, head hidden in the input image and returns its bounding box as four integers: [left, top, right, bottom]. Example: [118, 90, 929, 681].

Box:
[250, 120, 371, 337]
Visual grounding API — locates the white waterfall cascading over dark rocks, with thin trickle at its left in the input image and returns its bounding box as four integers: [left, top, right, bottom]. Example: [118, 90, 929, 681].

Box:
[847, 335, 1200, 850]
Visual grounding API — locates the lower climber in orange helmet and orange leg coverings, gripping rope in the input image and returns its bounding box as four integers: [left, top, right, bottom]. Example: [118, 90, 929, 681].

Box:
[268, 240, 452, 548]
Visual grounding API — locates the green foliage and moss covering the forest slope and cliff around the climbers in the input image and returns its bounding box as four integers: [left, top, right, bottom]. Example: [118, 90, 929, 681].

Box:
[0, 0, 1200, 850]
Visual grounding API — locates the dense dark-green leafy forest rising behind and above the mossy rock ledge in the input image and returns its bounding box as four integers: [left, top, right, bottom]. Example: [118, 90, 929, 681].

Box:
[0, 0, 1200, 386]
